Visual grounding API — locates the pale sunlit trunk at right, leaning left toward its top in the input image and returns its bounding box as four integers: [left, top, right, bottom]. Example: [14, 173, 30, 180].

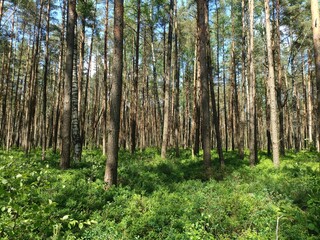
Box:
[264, 0, 280, 168]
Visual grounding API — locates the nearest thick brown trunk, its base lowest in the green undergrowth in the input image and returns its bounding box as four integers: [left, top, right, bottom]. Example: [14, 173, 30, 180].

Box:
[104, 0, 123, 189]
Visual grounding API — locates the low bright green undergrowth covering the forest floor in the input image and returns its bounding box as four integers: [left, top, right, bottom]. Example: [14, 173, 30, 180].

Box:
[0, 149, 320, 240]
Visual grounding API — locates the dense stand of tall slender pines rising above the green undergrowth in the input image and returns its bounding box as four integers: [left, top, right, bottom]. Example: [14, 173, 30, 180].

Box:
[0, 0, 320, 176]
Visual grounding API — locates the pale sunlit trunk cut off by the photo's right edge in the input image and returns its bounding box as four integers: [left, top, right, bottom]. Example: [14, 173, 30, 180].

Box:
[310, 0, 320, 152]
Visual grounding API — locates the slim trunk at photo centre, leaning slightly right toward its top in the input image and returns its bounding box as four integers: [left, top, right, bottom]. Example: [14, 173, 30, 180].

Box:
[161, 0, 174, 158]
